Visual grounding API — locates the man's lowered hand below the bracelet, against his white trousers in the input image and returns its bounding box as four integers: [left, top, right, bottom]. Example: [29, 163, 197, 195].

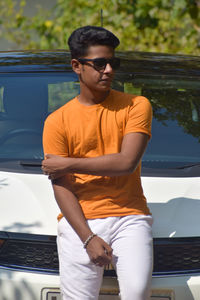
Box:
[86, 236, 112, 267]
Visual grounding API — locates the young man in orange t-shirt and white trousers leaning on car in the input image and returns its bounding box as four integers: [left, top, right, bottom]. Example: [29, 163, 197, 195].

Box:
[42, 26, 152, 300]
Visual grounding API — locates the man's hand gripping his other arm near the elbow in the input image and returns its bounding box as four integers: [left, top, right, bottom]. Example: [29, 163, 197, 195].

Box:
[42, 154, 68, 179]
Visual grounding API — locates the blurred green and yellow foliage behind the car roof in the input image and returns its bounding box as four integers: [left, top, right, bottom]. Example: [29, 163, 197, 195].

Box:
[0, 0, 200, 55]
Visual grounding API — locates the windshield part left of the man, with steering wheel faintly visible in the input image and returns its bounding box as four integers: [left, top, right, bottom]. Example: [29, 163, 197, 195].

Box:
[0, 73, 79, 160]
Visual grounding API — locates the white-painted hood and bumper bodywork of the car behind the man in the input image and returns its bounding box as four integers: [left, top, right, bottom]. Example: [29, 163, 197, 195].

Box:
[0, 172, 200, 300]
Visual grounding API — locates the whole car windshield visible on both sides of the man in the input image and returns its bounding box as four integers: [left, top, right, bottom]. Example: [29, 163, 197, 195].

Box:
[0, 72, 200, 172]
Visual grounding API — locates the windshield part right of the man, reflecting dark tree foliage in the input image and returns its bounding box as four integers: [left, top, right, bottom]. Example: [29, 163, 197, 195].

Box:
[115, 75, 200, 168]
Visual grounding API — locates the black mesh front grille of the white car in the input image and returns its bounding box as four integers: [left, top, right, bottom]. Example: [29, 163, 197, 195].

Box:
[0, 232, 200, 276]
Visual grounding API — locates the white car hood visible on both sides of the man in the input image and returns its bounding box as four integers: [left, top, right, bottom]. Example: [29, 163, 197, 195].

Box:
[0, 172, 200, 237]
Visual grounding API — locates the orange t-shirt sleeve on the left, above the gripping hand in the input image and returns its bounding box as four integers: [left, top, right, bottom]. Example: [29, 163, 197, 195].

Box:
[43, 114, 69, 157]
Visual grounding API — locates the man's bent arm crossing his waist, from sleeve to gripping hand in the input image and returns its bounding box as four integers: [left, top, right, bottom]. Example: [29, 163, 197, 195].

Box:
[42, 133, 148, 179]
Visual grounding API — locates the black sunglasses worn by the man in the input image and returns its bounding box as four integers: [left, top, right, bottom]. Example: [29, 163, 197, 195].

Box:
[78, 57, 120, 71]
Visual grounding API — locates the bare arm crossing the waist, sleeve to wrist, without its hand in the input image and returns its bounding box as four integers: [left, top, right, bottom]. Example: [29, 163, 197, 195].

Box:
[62, 133, 148, 176]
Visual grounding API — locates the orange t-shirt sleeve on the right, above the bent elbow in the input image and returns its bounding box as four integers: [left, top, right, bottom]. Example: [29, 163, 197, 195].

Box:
[125, 96, 152, 137]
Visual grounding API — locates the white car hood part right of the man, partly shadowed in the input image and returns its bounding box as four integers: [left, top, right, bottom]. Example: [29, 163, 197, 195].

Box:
[142, 177, 200, 237]
